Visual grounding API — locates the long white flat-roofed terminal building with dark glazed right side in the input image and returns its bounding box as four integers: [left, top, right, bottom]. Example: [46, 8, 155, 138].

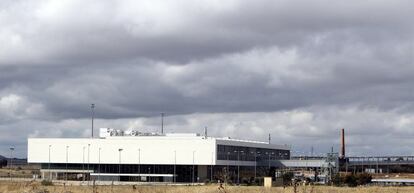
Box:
[28, 128, 290, 183]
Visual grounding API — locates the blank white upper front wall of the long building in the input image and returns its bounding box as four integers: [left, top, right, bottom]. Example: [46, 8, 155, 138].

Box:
[28, 136, 216, 165]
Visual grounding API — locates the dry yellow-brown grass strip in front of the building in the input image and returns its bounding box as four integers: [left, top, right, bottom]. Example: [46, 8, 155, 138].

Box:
[0, 181, 414, 193]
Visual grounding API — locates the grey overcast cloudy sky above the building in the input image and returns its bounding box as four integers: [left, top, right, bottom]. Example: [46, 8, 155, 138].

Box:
[0, 0, 414, 157]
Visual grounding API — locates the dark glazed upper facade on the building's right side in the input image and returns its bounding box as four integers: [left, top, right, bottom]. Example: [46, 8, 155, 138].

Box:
[217, 145, 290, 161]
